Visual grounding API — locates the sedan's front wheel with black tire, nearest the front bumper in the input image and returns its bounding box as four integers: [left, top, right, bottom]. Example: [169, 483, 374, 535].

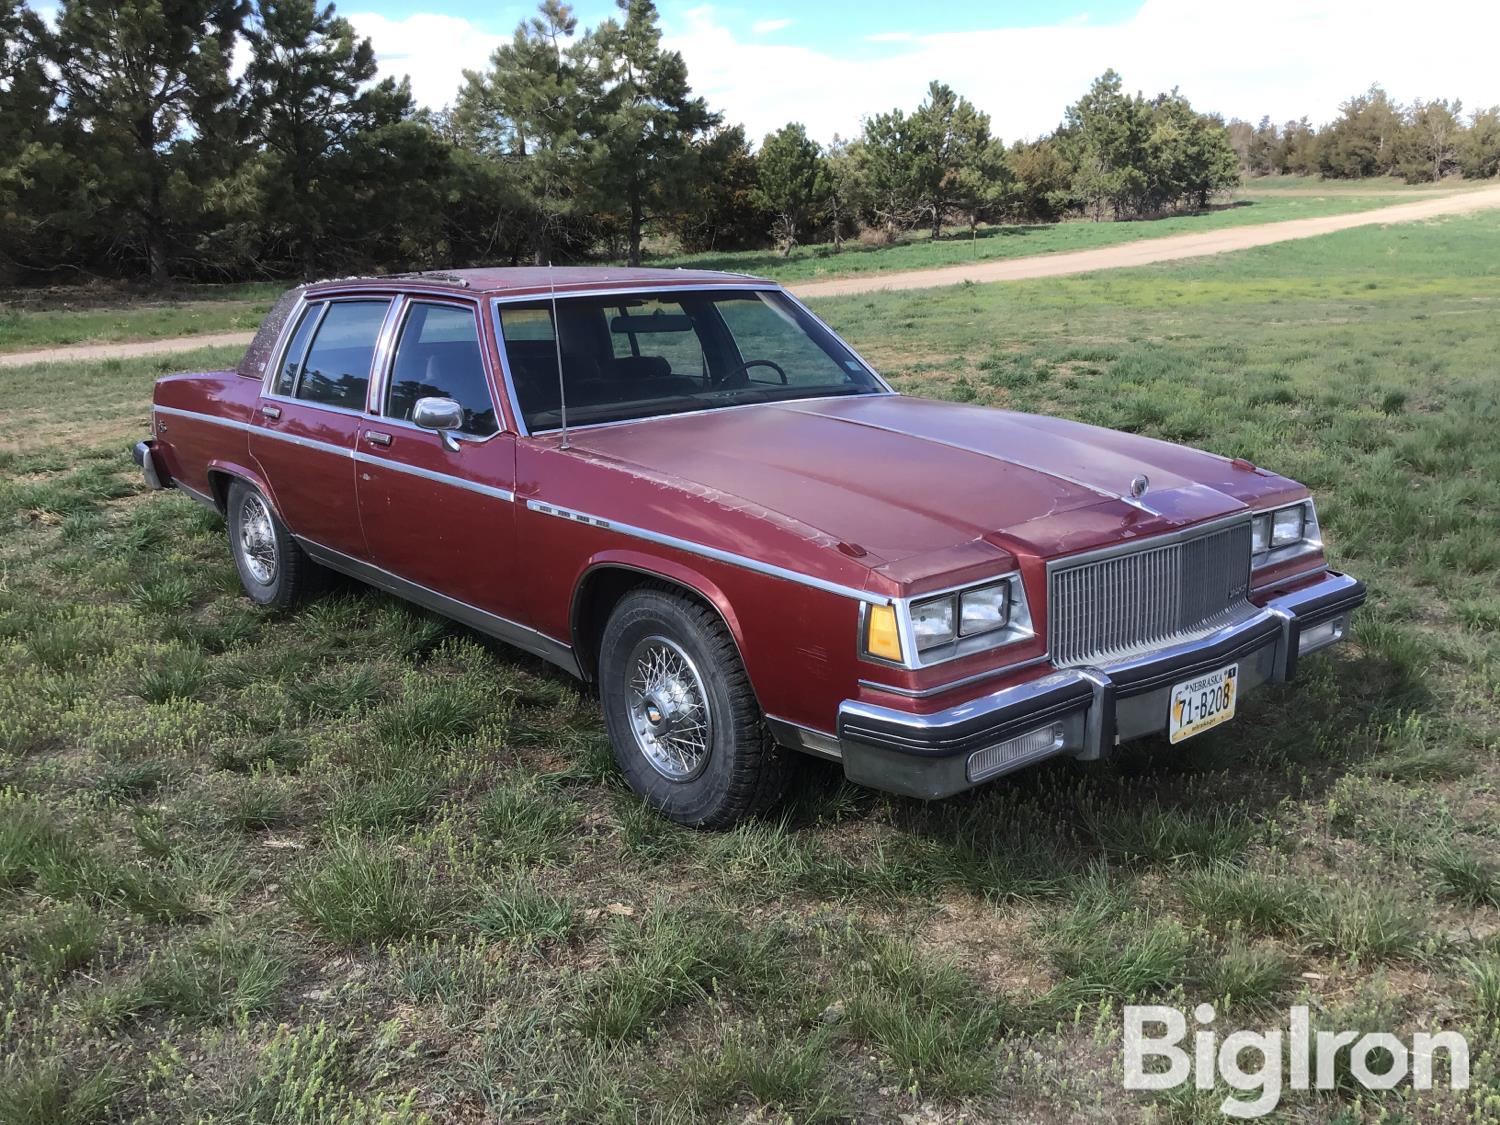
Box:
[599, 587, 791, 828]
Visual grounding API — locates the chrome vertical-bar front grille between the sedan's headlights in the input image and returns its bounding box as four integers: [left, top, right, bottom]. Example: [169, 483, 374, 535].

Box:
[1047, 521, 1250, 668]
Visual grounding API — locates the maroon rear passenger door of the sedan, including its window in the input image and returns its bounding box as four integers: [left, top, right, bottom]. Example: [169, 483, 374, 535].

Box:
[251, 297, 392, 558]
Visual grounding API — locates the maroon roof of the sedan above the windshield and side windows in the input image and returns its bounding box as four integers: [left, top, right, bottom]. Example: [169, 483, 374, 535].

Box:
[303, 266, 768, 296]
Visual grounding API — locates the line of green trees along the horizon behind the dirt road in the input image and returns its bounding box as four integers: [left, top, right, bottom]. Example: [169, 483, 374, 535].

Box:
[0, 0, 1500, 282]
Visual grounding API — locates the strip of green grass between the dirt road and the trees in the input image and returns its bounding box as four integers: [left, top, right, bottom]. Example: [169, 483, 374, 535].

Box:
[0, 177, 1452, 354]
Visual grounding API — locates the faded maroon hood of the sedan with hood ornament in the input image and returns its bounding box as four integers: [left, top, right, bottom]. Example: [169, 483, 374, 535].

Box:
[570, 395, 1299, 578]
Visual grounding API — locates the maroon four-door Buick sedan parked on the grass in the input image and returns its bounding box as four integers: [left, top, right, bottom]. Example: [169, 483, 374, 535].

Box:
[135, 269, 1365, 825]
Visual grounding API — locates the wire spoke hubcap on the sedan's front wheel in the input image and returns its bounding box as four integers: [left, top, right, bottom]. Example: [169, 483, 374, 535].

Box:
[626, 636, 714, 782]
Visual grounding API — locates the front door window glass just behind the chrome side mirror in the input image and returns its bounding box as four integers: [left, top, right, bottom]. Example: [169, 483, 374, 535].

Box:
[386, 302, 500, 438]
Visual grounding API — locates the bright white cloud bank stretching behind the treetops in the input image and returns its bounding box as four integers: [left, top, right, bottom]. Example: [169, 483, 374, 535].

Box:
[351, 0, 1500, 140]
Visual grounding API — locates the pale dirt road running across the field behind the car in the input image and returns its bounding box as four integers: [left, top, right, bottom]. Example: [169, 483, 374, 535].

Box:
[11, 188, 1500, 368]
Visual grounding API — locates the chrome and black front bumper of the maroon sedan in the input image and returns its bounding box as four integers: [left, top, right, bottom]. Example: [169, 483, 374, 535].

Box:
[837, 572, 1365, 798]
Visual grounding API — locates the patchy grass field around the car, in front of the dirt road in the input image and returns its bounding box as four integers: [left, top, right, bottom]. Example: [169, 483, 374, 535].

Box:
[0, 213, 1500, 1125]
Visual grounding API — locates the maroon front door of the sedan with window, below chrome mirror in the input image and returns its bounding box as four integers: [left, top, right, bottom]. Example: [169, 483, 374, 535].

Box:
[356, 297, 521, 621]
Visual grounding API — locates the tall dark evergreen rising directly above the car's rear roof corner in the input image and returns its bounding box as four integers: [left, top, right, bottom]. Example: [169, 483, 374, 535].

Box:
[243, 0, 413, 278]
